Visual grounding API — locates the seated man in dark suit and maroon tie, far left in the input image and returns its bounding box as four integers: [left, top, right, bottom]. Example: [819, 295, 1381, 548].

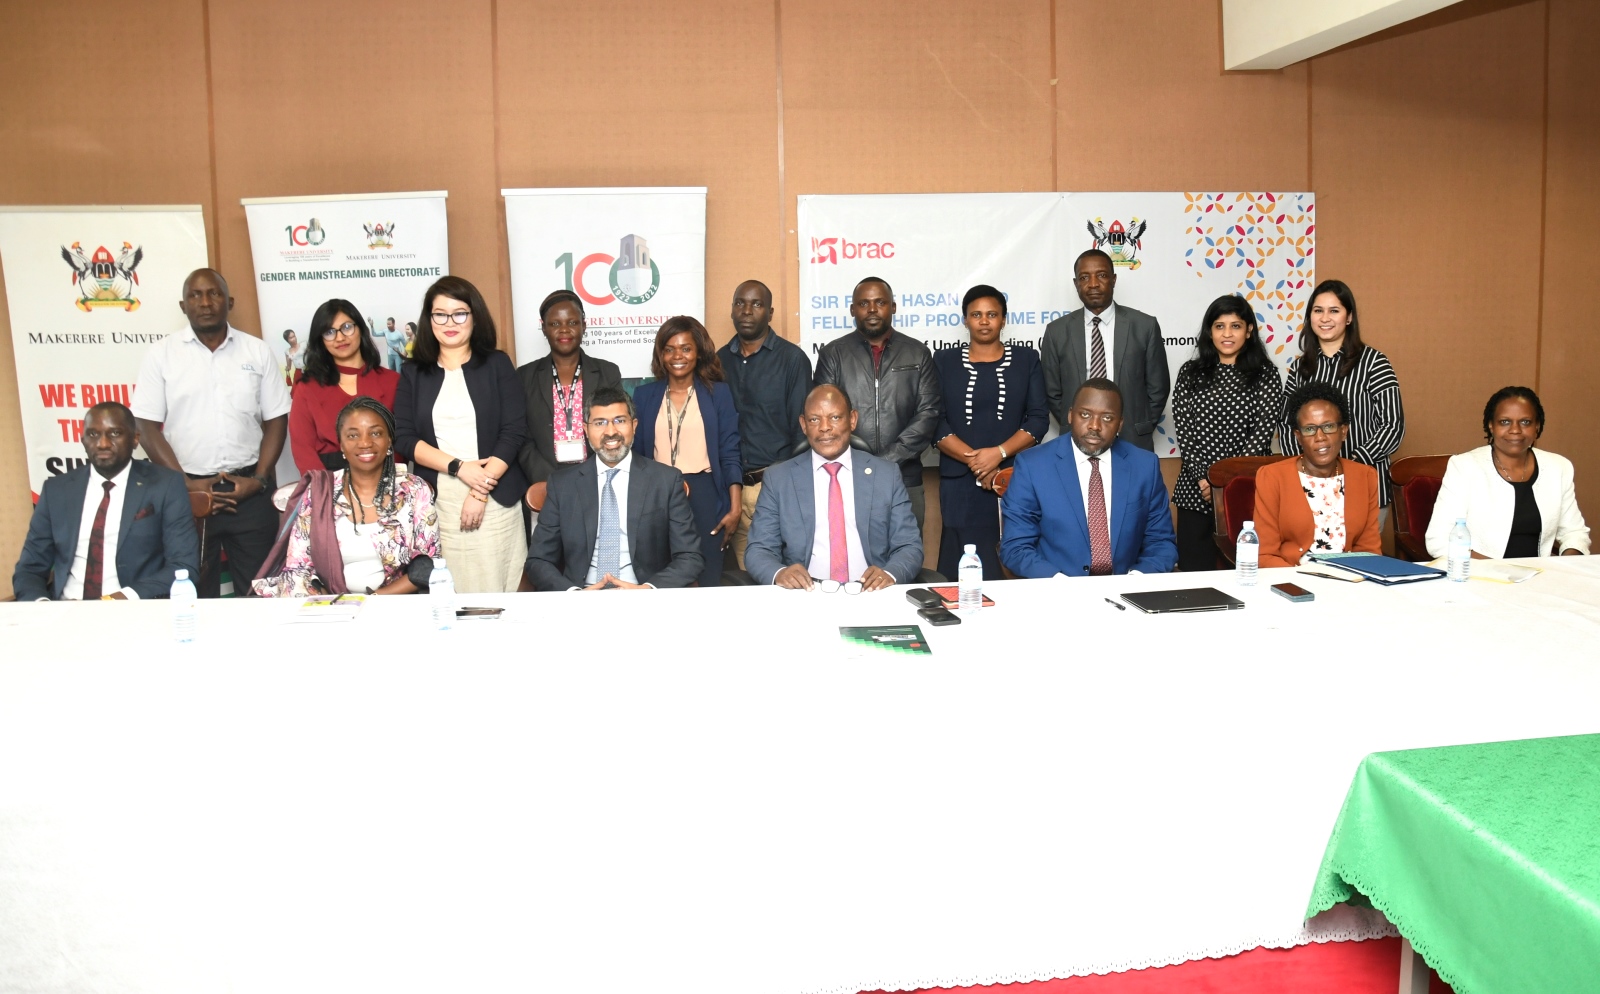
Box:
[11, 402, 200, 600]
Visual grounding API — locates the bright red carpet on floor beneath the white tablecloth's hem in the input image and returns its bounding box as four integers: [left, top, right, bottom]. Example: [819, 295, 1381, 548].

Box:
[874, 938, 1451, 994]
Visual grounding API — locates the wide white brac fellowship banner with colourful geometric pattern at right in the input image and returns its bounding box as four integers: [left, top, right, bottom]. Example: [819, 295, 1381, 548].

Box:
[797, 192, 1315, 456]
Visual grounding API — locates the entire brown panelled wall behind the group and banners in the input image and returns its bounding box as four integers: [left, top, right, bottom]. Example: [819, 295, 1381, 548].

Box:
[0, 0, 1600, 592]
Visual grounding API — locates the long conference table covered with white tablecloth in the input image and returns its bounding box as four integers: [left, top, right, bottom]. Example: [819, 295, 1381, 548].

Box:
[0, 559, 1600, 994]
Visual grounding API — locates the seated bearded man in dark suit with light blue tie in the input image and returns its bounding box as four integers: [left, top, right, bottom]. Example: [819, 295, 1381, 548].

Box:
[528, 387, 706, 591]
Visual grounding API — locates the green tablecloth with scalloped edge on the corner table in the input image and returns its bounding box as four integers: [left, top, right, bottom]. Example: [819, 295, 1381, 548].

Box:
[1306, 735, 1600, 994]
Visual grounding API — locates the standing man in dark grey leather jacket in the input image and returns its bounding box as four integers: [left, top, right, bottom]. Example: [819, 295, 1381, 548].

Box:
[816, 277, 944, 528]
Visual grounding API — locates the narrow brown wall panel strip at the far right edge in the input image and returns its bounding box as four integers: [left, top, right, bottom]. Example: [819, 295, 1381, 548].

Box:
[1538, 0, 1600, 509]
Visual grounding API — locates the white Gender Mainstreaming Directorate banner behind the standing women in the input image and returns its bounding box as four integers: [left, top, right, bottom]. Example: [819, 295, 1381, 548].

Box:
[240, 190, 450, 480]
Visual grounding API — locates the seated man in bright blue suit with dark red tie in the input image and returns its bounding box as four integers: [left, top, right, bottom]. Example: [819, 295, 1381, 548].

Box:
[1000, 378, 1178, 576]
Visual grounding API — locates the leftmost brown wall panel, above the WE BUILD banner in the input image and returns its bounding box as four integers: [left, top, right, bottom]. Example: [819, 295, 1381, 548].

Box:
[0, 0, 214, 597]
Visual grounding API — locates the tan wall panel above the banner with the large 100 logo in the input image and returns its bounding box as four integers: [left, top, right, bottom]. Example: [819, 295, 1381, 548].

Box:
[496, 0, 782, 343]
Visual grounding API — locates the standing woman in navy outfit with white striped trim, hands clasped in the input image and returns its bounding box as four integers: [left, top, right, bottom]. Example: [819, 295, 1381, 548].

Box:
[933, 285, 1050, 579]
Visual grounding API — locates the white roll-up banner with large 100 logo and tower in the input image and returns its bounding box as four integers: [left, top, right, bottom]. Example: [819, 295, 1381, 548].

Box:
[501, 186, 706, 381]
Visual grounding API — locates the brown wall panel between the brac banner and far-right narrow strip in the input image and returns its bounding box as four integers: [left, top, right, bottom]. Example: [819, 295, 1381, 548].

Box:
[1312, 3, 1544, 455]
